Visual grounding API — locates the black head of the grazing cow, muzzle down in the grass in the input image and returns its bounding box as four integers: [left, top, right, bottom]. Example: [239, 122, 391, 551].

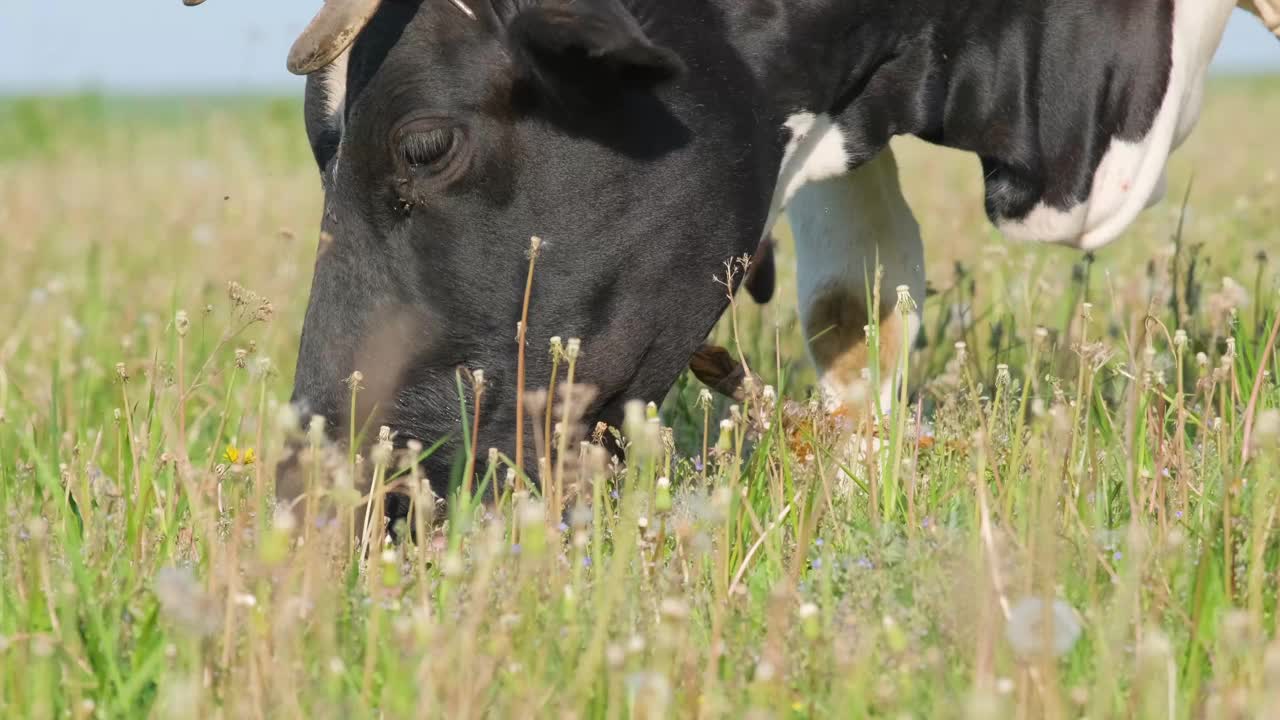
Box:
[188, 0, 781, 489]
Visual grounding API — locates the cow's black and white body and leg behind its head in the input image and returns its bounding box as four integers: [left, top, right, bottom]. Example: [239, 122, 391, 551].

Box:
[756, 0, 1234, 412]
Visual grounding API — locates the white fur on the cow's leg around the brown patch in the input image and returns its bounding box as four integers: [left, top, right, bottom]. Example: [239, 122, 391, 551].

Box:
[787, 147, 924, 409]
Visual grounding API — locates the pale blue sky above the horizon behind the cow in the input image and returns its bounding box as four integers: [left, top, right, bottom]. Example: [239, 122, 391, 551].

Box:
[0, 0, 1280, 92]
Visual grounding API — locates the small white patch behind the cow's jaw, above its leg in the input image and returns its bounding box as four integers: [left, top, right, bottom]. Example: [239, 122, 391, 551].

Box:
[764, 113, 849, 233]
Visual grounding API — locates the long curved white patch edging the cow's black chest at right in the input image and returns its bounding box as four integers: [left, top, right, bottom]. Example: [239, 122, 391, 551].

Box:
[996, 0, 1235, 250]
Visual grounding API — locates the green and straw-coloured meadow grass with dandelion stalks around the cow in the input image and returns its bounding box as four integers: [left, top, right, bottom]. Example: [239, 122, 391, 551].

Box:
[0, 78, 1280, 719]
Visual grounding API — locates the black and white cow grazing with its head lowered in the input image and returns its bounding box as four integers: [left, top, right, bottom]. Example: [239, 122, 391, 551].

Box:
[186, 0, 1276, 499]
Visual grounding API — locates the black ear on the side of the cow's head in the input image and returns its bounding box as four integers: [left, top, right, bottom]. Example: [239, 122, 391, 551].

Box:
[508, 0, 685, 90]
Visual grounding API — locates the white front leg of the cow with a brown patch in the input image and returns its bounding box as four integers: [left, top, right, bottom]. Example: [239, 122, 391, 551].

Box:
[788, 147, 924, 416]
